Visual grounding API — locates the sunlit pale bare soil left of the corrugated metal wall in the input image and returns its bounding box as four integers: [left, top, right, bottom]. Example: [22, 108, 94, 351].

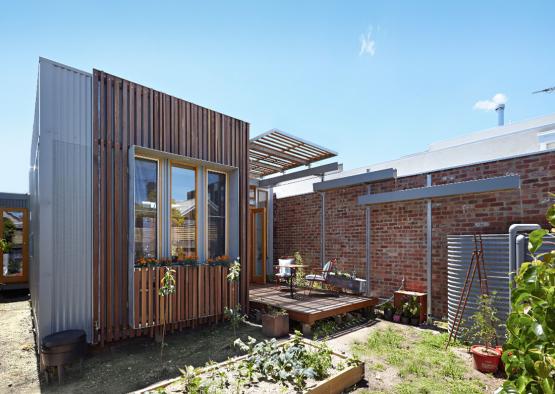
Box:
[0, 292, 40, 393]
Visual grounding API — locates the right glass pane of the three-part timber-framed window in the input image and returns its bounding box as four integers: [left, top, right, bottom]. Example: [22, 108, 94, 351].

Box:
[208, 171, 226, 258]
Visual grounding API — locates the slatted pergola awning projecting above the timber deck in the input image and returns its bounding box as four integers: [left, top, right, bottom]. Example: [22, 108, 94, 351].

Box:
[249, 129, 337, 178]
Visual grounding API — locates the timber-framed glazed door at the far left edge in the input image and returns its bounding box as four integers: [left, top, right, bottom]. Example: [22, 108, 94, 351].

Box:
[0, 208, 29, 283]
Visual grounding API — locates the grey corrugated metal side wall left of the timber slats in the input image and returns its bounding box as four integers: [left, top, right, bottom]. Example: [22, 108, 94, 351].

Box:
[29, 58, 92, 341]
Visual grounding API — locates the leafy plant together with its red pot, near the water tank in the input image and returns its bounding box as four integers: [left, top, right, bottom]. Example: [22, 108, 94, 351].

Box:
[470, 294, 502, 373]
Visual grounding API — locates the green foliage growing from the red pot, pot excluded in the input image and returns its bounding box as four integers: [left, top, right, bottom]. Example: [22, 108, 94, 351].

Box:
[470, 294, 500, 349]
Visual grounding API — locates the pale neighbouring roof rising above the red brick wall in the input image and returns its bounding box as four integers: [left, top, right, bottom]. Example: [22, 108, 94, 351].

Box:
[274, 114, 555, 198]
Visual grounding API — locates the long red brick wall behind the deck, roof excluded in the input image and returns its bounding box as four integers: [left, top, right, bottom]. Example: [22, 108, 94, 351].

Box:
[274, 153, 555, 317]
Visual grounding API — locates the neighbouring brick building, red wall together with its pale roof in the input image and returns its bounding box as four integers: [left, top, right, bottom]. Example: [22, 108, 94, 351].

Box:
[273, 112, 555, 317]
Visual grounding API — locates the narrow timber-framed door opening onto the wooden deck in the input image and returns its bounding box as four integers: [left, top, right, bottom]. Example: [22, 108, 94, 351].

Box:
[250, 208, 266, 284]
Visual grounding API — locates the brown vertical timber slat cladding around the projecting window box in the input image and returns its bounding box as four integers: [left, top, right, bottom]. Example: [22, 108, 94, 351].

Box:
[93, 70, 249, 343]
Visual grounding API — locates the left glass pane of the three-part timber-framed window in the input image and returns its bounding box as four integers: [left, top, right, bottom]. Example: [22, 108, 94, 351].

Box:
[135, 159, 158, 259]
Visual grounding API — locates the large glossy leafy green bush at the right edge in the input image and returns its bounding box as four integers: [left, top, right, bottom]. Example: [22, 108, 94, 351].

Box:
[502, 205, 555, 393]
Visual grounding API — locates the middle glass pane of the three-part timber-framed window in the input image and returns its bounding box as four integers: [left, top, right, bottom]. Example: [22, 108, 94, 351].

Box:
[171, 167, 197, 260]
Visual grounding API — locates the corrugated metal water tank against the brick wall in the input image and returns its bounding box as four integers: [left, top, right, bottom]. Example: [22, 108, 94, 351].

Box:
[447, 234, 510, 339]
